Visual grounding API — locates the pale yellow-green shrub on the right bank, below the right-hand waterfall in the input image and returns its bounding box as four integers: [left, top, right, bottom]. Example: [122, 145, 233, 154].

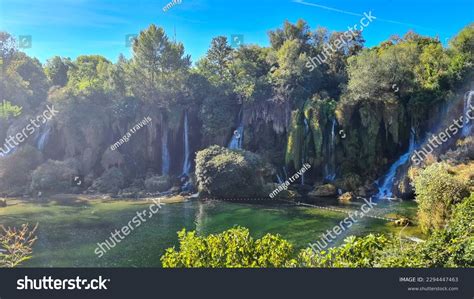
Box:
[414, 163, 469, 232]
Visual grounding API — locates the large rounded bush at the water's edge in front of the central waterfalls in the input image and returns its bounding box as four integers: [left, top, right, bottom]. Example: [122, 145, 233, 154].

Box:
[196, 145, 269, 198]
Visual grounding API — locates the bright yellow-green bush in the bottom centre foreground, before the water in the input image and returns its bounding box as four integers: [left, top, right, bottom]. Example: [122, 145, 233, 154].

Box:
[161, 227, 294, 268]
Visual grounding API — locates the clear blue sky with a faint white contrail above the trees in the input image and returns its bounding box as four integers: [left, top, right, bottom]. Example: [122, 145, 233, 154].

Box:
[0, 0, 474, 62]
